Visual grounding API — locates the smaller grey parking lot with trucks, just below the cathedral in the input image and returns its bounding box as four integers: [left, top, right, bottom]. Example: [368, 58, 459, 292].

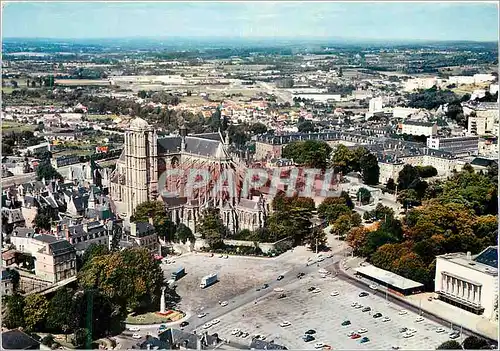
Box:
[162, 254, 305, 313]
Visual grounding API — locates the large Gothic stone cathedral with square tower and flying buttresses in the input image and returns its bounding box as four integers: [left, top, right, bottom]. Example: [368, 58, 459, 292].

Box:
[109, 118, 269, 233]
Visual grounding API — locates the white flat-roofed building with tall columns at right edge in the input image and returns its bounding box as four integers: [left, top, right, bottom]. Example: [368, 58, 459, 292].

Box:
[435, 246, 498, 320]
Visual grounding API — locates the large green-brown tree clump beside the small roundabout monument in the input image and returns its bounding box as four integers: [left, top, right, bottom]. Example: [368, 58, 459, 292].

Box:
[78, 248, 164, 311]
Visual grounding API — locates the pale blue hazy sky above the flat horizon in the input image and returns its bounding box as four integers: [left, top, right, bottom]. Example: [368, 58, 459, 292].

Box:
[2, 1, 498, 41]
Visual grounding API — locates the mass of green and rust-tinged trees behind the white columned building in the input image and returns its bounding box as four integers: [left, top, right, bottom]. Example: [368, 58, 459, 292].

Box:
[347, 167, 498, 288]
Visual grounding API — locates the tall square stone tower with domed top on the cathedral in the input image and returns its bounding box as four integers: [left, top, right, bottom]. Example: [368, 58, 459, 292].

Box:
[125, 118, 158, 217]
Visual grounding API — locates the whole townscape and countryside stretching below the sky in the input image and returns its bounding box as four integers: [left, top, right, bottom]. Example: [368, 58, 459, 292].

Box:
[1, 23, 499, 350]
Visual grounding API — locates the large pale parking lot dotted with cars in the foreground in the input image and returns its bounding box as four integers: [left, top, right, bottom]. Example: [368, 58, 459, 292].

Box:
[201, 273, 459, 350]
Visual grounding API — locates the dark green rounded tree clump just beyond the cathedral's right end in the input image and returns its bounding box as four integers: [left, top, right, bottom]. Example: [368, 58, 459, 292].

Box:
[282, 140, 332, 169]
